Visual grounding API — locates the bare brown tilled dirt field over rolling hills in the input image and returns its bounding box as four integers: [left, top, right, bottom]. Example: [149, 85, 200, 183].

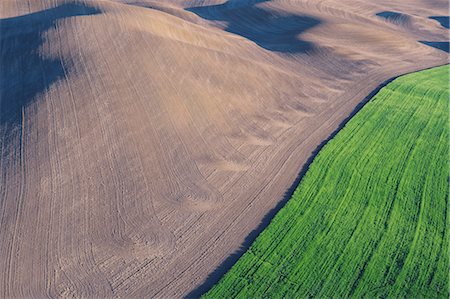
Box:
[0, 0, 448, 298]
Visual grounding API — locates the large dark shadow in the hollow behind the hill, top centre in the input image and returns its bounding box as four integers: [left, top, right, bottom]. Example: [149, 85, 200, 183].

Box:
[187, 0, 321, 53]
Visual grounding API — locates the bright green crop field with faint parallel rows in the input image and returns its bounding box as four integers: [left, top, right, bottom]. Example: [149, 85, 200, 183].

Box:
[204, 66, 449, 298]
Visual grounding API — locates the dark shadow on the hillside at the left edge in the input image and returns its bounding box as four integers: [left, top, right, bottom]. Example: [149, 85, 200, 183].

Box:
[0, 4, 100, 126]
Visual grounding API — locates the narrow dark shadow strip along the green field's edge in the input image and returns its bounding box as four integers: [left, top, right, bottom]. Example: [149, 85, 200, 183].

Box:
[185, 67, 448, 298]
